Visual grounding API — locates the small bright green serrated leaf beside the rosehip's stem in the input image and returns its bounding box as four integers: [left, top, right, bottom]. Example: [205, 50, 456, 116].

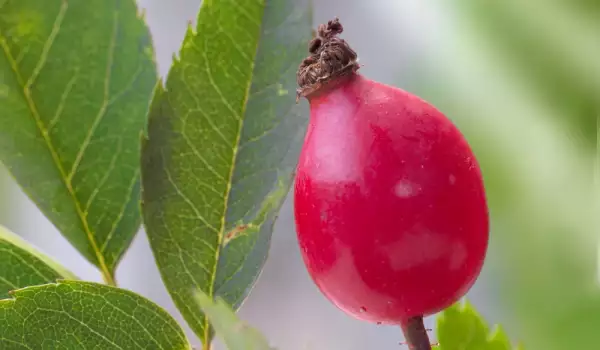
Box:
[437, 302, 513, 350]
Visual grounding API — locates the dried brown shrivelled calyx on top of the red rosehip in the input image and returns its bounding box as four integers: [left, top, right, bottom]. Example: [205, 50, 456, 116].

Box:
[296, 17, 359, 100]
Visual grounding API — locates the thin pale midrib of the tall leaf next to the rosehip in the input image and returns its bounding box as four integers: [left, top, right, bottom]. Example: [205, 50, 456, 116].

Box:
[200, 1, 266, 348]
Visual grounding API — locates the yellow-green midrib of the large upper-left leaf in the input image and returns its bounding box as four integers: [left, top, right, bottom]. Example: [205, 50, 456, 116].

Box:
[0, 1, 117, 285]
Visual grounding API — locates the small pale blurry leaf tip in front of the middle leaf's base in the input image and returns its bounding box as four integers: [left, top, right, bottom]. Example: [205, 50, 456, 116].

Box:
[196, 292, 274, 350]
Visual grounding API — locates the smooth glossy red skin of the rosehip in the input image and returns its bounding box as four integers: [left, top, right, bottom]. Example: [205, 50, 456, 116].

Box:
[294, 73, 489, 325]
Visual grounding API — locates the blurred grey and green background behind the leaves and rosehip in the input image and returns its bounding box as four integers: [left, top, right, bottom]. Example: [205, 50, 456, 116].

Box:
[0, 0, 600, 350]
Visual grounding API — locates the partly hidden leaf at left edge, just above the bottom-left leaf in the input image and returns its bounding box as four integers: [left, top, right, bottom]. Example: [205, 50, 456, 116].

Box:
[0, 225, 77, 299]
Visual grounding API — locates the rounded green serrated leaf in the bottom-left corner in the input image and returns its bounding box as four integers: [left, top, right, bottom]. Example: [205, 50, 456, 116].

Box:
[0, 281, 191, 350]
